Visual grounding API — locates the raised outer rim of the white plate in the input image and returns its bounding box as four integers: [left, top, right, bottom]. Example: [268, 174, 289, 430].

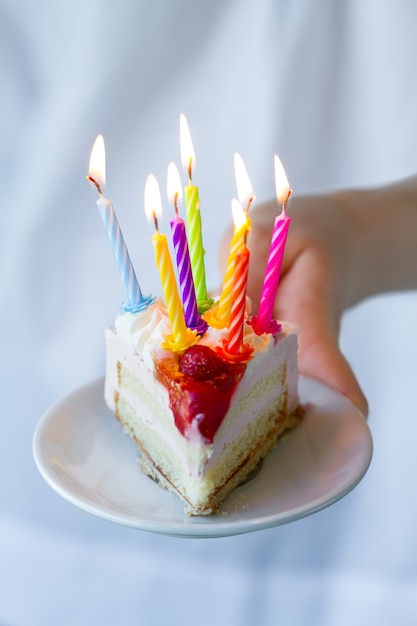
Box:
[32, 375, 373, 538]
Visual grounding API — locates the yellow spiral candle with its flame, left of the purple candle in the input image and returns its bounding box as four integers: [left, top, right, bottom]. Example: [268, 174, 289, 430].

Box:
[145, 174, 198, 353]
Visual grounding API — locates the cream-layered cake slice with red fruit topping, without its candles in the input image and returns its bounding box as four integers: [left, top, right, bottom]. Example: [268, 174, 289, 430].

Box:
[105, 299, 300, 515]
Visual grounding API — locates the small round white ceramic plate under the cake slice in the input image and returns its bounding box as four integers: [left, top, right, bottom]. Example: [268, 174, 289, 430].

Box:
[33, 377, 372, 537]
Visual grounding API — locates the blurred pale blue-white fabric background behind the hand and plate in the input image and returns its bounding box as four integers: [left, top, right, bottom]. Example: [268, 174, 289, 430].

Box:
[0, 0, 417, 626]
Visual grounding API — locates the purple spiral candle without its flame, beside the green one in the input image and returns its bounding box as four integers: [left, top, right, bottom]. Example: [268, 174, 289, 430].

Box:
[170, 215, 207, 335]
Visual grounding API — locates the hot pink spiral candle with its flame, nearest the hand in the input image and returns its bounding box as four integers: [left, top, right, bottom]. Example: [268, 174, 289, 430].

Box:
[252, 155, 292, 335]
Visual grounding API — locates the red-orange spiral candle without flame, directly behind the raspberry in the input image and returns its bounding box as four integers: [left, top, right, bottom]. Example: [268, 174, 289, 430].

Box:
[217, 243, 253, 362]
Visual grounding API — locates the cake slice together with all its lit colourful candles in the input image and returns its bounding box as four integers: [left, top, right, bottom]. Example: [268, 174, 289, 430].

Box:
[88, 116, 300, 515]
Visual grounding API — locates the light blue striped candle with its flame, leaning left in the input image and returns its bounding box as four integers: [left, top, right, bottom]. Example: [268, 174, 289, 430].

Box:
[87, 135, 154, 313]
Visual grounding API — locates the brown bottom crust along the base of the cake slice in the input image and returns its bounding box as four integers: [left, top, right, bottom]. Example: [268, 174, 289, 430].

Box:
[127, 407, 303, 516]
